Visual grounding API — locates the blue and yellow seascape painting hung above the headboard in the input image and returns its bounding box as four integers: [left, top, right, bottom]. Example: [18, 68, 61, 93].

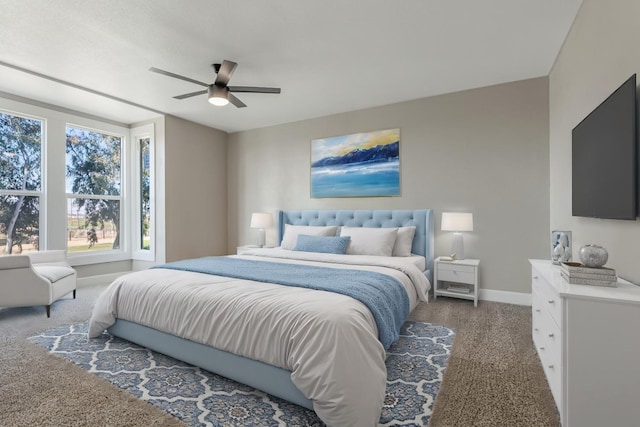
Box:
[311, 129, 400, 198]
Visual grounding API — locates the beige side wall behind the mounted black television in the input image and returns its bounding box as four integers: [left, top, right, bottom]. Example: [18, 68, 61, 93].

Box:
[549, 0, 640, 283]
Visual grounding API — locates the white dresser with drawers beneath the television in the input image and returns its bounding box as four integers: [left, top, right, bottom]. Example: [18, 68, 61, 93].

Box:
[529, 260, 640, 427]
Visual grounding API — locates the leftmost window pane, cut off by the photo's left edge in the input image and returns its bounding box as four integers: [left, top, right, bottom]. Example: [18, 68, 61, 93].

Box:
[0, 113, 43, 254]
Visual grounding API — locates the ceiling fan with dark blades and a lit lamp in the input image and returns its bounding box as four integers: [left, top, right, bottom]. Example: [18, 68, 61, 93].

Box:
[149, 59, 280, 108]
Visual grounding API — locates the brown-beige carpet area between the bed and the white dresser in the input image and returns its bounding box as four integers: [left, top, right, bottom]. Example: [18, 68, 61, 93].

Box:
[411, 298, 560, 427]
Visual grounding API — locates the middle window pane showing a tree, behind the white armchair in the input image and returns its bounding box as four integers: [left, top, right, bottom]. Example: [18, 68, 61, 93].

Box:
[66, 125, 124, 253]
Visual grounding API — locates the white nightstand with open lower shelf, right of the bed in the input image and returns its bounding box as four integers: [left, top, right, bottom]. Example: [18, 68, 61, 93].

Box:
[433, 257, 480, 307]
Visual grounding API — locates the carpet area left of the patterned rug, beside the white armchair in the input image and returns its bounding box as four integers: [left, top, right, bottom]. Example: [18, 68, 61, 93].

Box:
[0, 287, 185, 427]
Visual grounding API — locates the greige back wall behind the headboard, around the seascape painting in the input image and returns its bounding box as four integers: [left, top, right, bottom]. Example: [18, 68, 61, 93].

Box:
[228, 78, 550, 293]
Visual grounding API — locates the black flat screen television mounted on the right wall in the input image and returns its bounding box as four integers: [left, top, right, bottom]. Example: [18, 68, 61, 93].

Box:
[571, 74, 639, 220]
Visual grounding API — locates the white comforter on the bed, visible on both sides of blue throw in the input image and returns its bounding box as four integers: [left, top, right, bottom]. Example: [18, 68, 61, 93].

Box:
[89, 249, 430, 427]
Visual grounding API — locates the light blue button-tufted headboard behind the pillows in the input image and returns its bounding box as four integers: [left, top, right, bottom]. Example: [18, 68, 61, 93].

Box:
[277, 209, 434, 278]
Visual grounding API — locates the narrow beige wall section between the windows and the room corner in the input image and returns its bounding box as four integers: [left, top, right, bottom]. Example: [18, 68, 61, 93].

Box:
[165, 116, 227, 262]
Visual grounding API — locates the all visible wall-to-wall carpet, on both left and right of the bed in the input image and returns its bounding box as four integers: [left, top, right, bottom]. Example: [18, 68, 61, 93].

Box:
[0, 287, 559, 427]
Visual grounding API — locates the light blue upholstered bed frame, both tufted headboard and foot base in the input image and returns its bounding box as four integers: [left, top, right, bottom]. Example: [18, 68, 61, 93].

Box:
[108, 209, 434, 409]
